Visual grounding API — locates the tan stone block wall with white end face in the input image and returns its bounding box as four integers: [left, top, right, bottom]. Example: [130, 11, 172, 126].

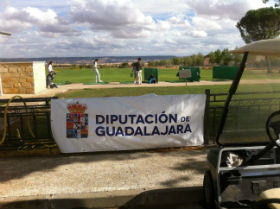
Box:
[0, 62, 46, 94]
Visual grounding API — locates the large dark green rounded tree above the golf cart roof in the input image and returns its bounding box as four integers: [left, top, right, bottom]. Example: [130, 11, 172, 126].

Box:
[236, 7, 280, 43]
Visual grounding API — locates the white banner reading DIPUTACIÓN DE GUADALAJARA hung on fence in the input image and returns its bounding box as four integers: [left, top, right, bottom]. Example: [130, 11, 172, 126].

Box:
[51, 94, 206, 153]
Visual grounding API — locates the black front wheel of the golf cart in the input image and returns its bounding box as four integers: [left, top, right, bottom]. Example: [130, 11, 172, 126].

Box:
[203, 170, 216, 209]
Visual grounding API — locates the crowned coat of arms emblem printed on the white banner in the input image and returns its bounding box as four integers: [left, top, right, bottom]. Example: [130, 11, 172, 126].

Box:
[66, 102, 88, 138]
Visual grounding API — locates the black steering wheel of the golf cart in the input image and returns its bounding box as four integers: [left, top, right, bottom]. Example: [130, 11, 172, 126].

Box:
[266, 111, 280, 147]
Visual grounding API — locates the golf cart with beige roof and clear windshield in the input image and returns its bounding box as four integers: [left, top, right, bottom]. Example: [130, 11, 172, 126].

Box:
[203, 39, 280, 209]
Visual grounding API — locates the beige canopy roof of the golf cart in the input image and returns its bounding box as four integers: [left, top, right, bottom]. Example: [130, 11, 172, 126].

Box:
[230, 38, 280, 56]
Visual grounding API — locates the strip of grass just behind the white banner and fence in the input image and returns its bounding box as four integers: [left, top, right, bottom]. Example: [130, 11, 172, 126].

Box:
[57, 83, 280, 100]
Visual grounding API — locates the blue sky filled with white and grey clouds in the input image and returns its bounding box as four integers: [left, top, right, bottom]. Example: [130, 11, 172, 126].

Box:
[0, 0, 269, 58]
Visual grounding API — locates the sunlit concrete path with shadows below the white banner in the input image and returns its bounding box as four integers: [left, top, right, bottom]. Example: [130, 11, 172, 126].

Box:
[0, 148, 207, 209]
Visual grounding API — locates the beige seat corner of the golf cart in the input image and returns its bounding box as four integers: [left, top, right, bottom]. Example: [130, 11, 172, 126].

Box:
[253, 188, 280, 209]
